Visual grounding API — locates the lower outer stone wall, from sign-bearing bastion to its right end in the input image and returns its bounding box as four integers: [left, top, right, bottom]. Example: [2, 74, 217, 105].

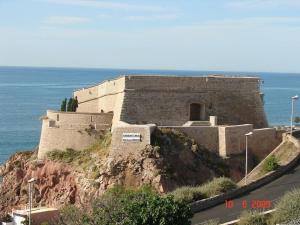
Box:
[111, 124, 282, 160]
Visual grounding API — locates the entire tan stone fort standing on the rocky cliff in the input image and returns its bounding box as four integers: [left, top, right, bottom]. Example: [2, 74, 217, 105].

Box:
[38, 75, 281, 159]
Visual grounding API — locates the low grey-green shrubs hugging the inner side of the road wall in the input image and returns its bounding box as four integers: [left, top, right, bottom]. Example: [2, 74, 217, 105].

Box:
[170, 177, 237, 203]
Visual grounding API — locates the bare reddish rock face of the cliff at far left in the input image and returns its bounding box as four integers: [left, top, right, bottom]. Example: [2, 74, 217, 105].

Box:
[0, 153, 88, 213]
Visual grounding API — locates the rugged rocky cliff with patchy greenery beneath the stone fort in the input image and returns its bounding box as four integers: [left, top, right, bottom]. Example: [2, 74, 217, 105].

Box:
[0, 129, 248, 213]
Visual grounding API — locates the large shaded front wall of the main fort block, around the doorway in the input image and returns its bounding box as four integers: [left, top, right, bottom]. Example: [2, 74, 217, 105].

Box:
[121, 76, 267, 128]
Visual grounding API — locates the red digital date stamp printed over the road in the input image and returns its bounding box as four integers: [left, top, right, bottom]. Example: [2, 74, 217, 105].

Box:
[225, 199, 272, 209]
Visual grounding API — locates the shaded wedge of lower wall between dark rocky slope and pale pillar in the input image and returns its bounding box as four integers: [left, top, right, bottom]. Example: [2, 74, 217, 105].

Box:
[161, 126, 219, 153]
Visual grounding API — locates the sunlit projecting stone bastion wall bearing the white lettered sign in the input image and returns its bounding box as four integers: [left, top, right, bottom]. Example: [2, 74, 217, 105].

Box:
[110, 125, 155, 157]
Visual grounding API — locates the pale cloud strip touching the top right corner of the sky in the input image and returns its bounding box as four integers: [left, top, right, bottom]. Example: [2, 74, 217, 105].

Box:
[228, 0, 300, 9]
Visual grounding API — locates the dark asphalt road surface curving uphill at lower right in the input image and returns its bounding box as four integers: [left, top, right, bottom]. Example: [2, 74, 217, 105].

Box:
[192, 163, 300, 225]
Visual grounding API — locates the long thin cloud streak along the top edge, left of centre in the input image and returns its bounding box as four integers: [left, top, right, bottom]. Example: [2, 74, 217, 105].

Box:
[47, 0, 164, 12]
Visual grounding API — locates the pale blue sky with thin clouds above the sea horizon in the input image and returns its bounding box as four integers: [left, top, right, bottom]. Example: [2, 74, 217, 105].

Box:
[0, 0, 300, 73]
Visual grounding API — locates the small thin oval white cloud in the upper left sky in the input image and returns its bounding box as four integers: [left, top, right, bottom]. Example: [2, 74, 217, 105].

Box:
[44, 16, 91, 25]
